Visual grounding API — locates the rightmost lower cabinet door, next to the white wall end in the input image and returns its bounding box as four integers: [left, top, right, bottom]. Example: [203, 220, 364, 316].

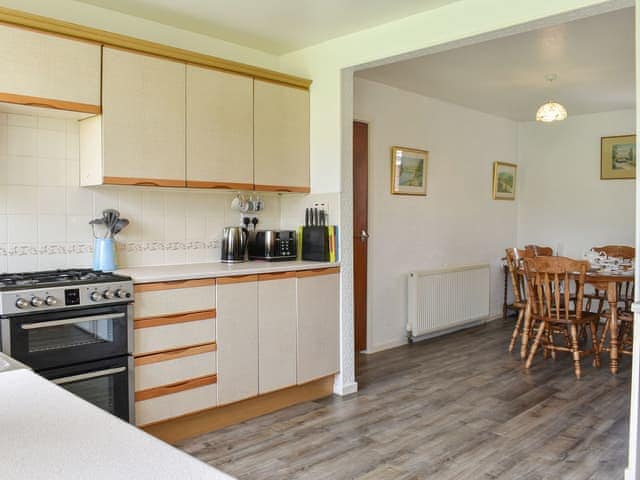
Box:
[298, 268, 340, 384]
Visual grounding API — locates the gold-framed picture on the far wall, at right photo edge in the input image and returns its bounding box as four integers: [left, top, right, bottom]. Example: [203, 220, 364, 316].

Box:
[600, 135, 636, 180]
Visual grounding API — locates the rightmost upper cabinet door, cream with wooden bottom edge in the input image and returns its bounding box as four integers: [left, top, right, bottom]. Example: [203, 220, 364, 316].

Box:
[253, 80, 309, 192]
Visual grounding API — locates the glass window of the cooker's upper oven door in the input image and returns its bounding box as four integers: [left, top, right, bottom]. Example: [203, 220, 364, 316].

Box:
[28, 319, 114, 353]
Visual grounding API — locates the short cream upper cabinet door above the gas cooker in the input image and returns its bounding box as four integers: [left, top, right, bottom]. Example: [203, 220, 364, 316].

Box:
[0, 25, 101, 109]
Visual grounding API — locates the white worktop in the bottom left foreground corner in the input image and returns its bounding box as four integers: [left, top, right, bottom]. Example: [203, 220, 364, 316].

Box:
[0, 370, 232, 480]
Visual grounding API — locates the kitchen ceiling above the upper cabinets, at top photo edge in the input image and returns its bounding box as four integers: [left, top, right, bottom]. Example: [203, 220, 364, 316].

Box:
[74, 0, 456, 54]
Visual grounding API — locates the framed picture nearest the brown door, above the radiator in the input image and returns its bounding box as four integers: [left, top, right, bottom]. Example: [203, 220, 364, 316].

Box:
[391, 147, 429, 195]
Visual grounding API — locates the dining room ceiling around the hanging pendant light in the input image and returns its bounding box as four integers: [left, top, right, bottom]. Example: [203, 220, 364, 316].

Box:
[356, 8, 635, 121]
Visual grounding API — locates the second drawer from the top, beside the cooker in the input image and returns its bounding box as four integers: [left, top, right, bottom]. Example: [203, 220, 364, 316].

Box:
[133, 310, 216, 356]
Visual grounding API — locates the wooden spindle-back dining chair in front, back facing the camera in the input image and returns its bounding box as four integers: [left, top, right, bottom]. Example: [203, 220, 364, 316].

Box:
[524, 257, 600, 378]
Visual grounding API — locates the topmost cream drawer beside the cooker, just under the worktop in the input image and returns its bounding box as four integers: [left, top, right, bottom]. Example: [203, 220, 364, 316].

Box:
[133, 279, 216, 318]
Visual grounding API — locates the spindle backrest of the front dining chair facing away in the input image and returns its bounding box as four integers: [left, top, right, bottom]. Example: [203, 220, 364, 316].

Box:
[524, 257, 589, 321]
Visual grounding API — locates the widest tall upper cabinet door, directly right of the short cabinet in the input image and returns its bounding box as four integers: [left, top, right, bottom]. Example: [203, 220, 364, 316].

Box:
[102, 47, 186, 186]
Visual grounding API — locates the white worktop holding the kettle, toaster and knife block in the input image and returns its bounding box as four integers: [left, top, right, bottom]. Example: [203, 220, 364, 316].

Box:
[115, 260, 339, 283]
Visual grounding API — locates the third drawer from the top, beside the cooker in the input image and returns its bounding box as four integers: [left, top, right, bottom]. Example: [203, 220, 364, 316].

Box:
[135, 343, 216, 392]
